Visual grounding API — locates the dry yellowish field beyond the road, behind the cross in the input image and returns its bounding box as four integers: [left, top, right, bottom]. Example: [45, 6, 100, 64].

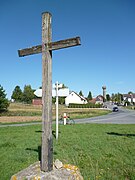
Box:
[0, 103, 109, 123]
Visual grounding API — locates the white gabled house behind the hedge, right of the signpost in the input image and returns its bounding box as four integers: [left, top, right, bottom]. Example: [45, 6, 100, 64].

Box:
[65, 91, 87, 106]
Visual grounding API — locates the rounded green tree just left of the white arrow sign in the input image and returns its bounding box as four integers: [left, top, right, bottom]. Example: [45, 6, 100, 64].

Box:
[22, 85, 34, 104]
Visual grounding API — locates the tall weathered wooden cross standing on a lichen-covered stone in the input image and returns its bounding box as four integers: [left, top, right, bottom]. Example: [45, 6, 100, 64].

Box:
[18, 12, 80, 172]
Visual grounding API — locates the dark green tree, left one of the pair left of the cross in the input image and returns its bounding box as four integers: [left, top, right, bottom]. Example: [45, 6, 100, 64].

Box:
[11, 86, 23, 102]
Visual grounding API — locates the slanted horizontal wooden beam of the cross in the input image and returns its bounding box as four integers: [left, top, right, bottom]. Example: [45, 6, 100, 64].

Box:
[18, 37, 81, 57]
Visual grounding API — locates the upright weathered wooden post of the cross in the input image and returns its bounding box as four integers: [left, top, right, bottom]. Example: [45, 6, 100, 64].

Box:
[41, 13, 53, 172]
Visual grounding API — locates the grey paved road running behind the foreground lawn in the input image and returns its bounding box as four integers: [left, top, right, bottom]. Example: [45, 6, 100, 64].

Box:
[0, 107, 135, 127]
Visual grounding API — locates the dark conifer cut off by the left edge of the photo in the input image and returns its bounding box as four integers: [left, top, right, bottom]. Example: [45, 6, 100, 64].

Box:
[0, 85, 9, 112]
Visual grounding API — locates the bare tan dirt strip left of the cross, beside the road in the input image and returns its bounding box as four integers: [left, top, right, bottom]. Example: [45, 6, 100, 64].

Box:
[0, 116, 41, 123]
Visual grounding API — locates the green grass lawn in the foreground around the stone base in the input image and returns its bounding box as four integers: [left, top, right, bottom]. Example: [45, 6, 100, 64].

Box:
[0, 124, 135, 180]
